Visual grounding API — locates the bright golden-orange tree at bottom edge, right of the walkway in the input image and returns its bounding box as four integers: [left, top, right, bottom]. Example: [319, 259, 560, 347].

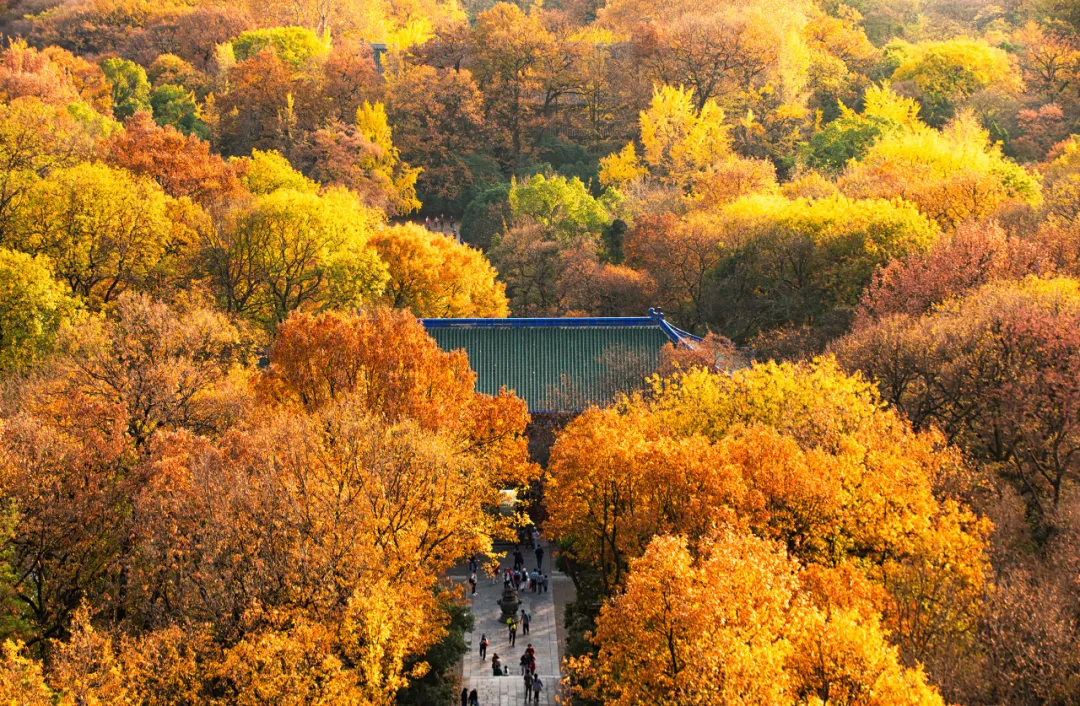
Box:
[567, 537, 944, 706]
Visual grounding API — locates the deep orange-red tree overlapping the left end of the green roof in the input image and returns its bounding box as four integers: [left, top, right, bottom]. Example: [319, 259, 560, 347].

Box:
[264, 309, 535, 480]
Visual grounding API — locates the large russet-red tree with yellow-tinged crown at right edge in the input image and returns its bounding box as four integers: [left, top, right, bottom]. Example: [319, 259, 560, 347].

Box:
[835, 277, 1080, 541]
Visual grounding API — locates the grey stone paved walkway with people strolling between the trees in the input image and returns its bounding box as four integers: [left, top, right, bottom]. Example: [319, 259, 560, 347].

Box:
[456, 546, 562, 706]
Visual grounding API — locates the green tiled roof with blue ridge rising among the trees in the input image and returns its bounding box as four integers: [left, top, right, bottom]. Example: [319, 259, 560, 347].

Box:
[422, 315, 693, 412]
